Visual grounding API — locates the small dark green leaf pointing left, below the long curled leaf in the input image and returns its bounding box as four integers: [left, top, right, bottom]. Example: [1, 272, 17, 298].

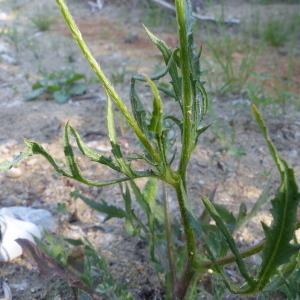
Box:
[73, 192, 126, 222]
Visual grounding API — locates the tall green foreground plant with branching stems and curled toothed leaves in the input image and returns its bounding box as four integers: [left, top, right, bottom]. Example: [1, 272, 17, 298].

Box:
[0, 0, 300, 300]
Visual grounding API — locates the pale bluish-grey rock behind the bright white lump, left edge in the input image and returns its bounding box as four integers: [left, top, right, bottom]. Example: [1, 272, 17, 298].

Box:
[0, 206, 57, 231]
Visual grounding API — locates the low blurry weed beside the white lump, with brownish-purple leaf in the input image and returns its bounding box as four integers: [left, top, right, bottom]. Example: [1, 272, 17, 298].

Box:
[17, 233, 133, 300]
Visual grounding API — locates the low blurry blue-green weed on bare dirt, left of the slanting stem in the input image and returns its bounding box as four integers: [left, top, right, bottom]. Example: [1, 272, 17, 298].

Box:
[25, 70, 87, 104]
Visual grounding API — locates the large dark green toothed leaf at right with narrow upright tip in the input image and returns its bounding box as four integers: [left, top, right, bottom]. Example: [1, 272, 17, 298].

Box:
[252, 105, 300, 291]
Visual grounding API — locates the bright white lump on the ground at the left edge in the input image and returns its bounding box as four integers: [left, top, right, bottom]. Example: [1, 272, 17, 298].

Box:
[0, 214, 42, 261]
